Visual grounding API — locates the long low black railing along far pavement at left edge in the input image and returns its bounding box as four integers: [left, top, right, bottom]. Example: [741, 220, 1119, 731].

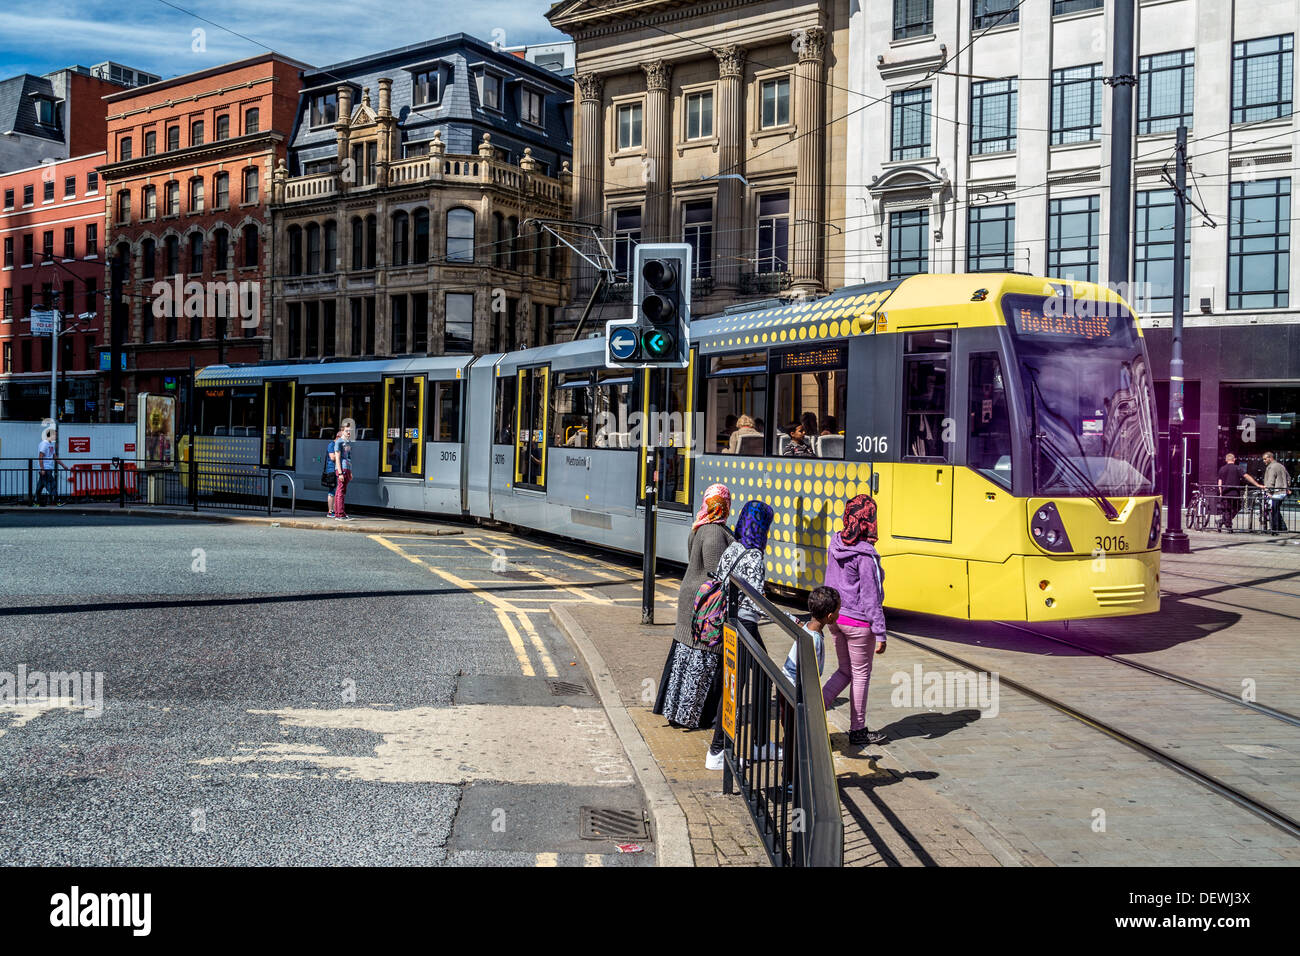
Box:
[0, 458, 298, 514]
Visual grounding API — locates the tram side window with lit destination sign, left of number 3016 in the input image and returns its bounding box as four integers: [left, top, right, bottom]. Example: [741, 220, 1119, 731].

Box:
[771, 345, 849, 460]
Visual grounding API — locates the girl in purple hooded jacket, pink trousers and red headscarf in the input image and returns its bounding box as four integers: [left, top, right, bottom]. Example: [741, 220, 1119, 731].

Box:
[822, 494, 889, 747]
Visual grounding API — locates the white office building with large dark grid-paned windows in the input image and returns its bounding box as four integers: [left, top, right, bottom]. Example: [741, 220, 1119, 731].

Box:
[837, 0, 1300, 489]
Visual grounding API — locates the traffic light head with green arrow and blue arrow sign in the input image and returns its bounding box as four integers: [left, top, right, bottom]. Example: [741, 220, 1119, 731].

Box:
[605, 242, 692, 368]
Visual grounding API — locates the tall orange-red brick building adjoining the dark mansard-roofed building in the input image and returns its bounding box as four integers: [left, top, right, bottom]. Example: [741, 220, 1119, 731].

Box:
[100, 53, 307, 420]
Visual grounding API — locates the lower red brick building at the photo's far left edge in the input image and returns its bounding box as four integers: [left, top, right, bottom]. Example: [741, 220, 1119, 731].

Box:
[0, 152, 104, 421]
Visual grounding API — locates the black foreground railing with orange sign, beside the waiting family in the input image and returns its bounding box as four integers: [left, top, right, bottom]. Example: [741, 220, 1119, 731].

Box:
[723, 575, 844, 866]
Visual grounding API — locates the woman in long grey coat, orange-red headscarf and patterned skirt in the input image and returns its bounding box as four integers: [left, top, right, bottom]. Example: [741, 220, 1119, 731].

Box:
[654, 484, 732, 728]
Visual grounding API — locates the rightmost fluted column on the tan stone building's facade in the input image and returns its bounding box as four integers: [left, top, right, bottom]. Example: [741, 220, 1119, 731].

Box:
[790, 26, 827, 293]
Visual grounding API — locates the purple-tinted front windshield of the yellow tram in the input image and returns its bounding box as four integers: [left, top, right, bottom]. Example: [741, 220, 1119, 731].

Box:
[1002, 295, 1156, 509]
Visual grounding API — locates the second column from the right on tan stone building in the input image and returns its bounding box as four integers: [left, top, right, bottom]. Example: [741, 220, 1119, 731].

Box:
[714, 46, 745, 293]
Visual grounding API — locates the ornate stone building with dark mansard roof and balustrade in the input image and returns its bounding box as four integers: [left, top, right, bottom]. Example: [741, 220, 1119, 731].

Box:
[272, 34, 572, 360]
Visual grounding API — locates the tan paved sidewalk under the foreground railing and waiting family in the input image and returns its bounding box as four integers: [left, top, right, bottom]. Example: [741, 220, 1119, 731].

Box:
[556, 605, 1013, 866]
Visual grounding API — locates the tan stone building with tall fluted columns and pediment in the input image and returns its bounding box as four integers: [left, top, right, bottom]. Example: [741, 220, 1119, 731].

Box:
[547, 0, 854, 317]
